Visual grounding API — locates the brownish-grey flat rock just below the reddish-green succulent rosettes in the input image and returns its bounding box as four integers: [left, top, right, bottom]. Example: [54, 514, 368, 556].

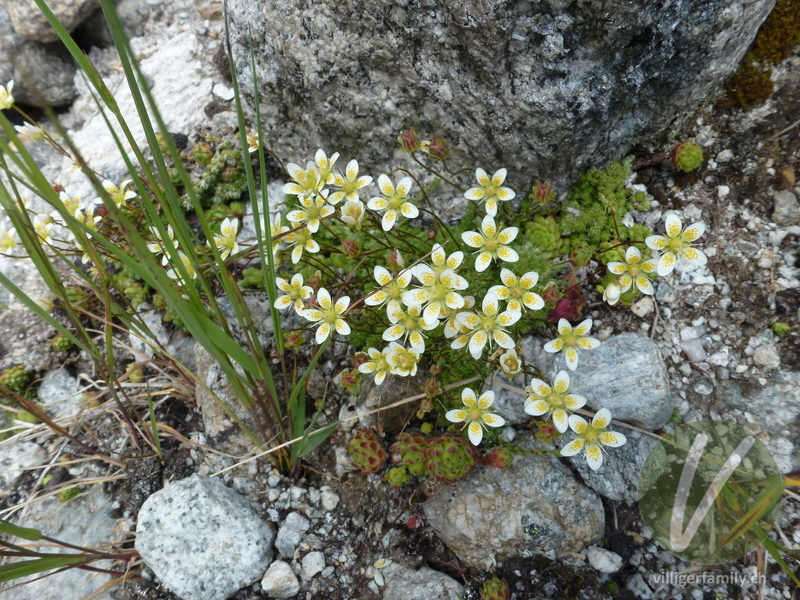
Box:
[424, 456, 605, 569]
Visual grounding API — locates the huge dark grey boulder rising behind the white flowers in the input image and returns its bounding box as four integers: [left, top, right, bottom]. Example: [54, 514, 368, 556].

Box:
[228, 0, 774, 185]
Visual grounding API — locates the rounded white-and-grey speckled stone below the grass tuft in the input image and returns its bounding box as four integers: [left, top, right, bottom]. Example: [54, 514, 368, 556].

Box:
[136, 475, 275, 600]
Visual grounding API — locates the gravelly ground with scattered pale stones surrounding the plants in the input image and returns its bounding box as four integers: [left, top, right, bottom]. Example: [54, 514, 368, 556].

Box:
[0, 0, 800, 600]
